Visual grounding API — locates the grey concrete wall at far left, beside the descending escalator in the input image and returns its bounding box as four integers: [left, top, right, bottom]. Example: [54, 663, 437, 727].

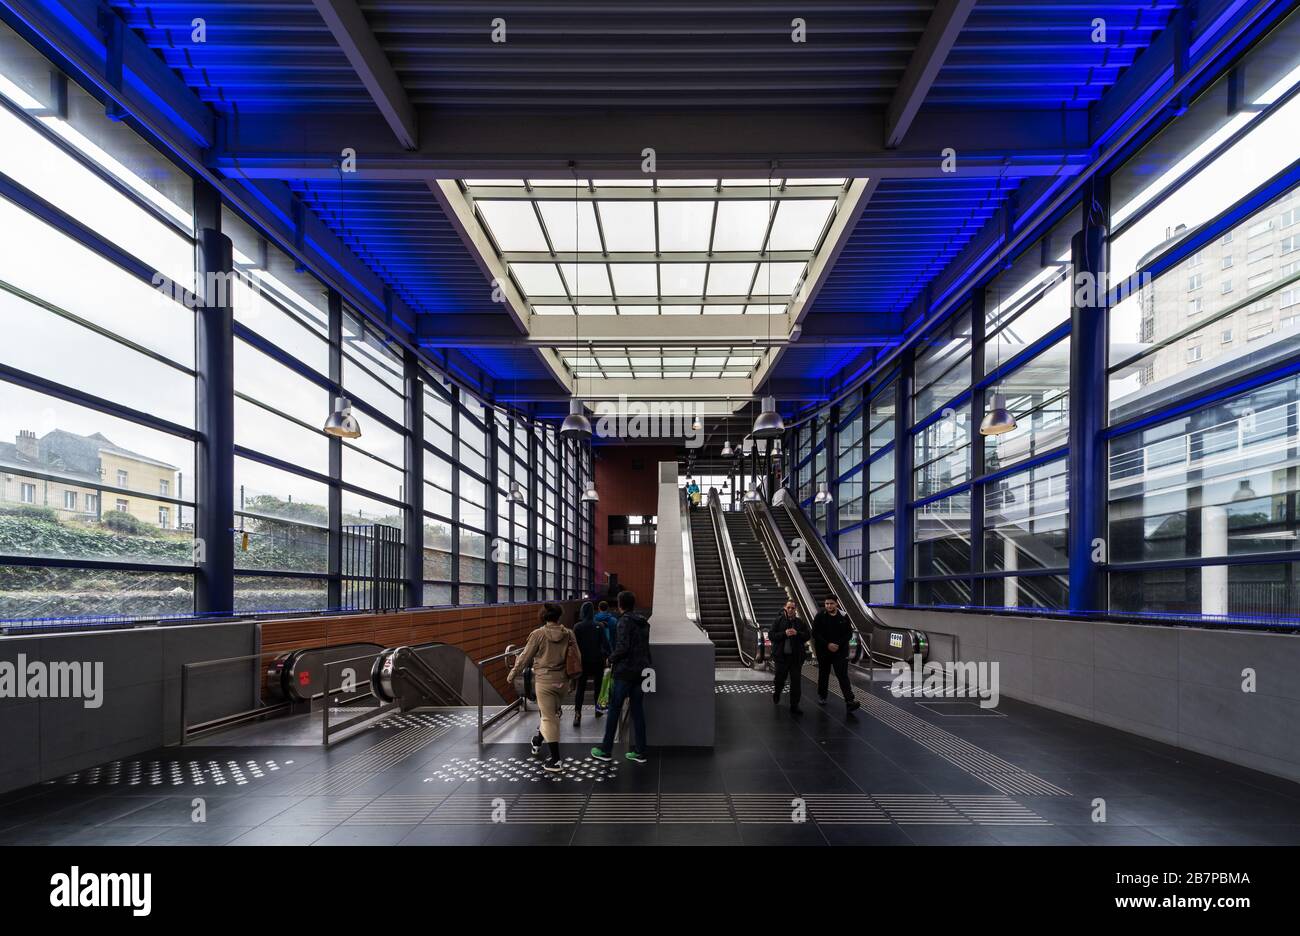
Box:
[0, 623, 260, 792]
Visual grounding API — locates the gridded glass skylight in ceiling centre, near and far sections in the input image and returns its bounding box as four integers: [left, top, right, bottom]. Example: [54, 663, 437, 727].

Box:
[462, 177, 848, 378]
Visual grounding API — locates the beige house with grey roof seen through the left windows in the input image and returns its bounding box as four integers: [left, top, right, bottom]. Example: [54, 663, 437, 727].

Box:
[0, 429, 183, 529]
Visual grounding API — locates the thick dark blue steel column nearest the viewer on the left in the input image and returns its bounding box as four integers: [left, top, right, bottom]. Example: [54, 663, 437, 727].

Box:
[194, 185, 235, 615]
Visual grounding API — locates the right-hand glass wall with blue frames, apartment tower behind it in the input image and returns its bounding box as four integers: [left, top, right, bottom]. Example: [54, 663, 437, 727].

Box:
[792, 3, 1300, 627]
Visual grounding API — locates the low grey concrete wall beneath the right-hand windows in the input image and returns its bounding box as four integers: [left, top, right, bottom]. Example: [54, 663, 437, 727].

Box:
[876, 608, 1300, 780]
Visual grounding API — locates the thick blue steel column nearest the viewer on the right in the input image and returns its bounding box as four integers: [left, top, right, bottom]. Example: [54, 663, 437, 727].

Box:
[1070, 185, 1109, 611]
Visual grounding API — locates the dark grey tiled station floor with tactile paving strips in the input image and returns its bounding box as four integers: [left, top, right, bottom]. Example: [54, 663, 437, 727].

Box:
[0, 670, 1300, 845]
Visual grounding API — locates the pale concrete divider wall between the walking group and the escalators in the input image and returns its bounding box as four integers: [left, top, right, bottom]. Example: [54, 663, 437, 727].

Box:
[646, 462, 715, 748]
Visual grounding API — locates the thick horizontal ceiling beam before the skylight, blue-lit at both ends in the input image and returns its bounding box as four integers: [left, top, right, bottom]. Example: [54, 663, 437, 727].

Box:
[211, 105, 1088, 180]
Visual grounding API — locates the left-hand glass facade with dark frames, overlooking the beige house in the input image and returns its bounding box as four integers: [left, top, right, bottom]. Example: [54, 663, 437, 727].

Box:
[0, 26, 593, 623]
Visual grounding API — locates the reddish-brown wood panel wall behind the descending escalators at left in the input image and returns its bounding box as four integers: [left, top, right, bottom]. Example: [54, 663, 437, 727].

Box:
[257, 602, 581, 701]
